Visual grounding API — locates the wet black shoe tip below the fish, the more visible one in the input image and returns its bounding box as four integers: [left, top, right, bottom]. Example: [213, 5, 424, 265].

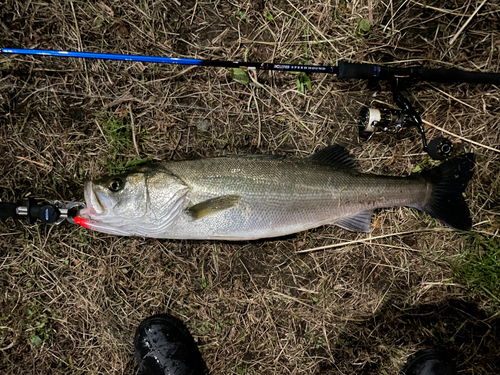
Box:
[134, 314, 206, 375]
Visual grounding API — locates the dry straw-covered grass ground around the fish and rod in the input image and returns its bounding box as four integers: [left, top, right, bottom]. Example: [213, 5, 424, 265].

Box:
[0, 0, 500, 375]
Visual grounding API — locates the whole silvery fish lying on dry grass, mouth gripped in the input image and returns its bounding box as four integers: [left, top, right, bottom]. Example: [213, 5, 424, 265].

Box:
[75, 145, 474, 241]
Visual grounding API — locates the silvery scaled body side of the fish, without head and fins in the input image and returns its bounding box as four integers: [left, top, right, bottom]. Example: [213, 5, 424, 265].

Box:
[160, 158, 429, 239]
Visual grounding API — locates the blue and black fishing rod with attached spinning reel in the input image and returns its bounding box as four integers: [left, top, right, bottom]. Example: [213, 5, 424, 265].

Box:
[1, 48, 500, 160]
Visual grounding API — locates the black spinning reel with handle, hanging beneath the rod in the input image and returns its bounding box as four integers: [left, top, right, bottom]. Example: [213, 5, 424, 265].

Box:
[358, 81, 453, 160]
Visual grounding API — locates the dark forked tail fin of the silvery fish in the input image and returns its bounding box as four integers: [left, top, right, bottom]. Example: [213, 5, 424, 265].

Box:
[416, 154, 474, 230]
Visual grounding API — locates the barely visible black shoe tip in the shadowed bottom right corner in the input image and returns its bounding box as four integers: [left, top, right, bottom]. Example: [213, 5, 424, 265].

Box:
[400, 349, 457, 375]
